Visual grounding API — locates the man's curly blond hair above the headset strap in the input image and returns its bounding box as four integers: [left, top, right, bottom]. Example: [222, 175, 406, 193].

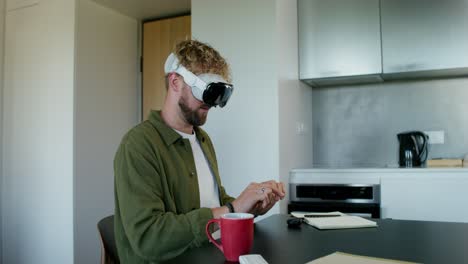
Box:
[174, 40, 231, 82]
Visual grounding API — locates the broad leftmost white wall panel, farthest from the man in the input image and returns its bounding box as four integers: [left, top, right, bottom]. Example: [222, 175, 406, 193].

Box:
[2, 0, 75, 264]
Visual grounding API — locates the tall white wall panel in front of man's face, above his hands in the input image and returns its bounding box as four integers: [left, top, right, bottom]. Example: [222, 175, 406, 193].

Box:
[192, 0, 279, 214]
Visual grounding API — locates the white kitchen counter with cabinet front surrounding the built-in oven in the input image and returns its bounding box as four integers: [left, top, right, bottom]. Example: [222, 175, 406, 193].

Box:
[289, 167, 468, 223]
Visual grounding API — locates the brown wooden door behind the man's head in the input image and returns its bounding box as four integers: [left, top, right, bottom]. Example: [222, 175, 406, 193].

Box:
[142, 16, 191, 119]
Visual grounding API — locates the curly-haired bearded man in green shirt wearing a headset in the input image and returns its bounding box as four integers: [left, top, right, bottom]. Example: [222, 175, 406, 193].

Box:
[114, 40, 285, 264]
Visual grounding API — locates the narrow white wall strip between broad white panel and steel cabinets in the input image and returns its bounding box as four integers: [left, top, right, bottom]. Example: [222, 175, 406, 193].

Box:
[276, 0, 313, 213]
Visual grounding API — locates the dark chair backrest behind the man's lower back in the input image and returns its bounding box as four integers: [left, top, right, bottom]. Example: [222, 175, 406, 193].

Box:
[98, 215, 120, 264]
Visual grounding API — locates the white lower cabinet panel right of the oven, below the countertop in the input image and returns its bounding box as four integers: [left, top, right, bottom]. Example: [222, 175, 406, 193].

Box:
[380, 175, 468, 222]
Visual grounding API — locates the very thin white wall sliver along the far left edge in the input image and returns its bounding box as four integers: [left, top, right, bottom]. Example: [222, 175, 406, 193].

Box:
[0, 0, 5, 262]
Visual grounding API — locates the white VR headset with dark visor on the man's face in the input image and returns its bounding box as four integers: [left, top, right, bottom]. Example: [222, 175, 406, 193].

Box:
[164, 53, 234, 107]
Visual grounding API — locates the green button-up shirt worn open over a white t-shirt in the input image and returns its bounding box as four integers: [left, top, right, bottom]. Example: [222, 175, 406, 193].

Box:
[114, 111, 234, 264]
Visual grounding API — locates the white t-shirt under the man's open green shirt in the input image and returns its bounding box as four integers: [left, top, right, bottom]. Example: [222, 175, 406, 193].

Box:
[174, 129, 220, 208]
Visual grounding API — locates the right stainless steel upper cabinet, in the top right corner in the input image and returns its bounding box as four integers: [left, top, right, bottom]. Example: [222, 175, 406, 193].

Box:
[381, 0, 468, 78]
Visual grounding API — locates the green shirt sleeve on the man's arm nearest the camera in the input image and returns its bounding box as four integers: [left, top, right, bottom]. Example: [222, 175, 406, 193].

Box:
[114, 134, 213, 262]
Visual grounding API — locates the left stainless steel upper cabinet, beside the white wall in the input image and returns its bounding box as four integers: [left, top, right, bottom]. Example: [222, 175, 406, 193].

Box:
[298, 0, 382, 86]
